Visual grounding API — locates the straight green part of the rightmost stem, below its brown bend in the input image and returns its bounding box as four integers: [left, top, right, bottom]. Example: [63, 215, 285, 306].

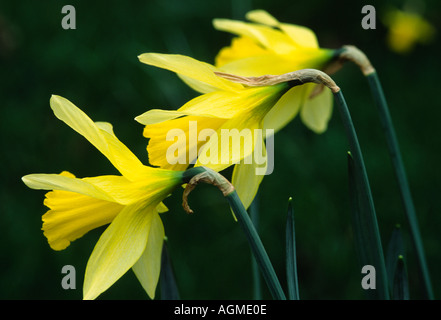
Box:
[366, 72, 434, 300]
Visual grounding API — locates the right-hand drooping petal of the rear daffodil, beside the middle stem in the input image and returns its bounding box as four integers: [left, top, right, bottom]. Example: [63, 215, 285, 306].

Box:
[300, 84, 333, 133]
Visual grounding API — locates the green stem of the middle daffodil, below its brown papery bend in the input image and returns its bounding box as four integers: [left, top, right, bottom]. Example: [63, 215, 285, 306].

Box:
[334, 90, 389, 300]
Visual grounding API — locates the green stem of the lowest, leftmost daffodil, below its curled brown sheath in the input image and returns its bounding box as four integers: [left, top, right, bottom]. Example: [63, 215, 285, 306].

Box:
[226, 190, 286, 300]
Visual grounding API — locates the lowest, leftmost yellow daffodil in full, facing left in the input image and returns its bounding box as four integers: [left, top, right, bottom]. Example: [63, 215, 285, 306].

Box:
[22, 96, 183, 299]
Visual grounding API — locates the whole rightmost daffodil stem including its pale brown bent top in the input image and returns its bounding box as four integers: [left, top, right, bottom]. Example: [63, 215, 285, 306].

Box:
[338, 46, 434, 300]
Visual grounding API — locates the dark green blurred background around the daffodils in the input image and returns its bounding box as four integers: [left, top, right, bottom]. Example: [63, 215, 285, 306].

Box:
[0, 0, 441, 299]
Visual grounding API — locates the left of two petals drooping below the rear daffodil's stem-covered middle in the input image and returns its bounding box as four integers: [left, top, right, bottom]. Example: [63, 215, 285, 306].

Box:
[263, 86, 306, 133]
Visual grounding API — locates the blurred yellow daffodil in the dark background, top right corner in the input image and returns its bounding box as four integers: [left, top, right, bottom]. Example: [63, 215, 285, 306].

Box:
[384, 9, 435, 54]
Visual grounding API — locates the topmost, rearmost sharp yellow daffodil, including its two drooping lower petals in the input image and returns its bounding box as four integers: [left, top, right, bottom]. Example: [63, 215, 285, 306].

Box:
[213, 10, 335, 133]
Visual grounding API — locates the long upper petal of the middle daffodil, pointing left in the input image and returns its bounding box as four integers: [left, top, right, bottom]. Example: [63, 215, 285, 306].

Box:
[138, 53, 242, 90]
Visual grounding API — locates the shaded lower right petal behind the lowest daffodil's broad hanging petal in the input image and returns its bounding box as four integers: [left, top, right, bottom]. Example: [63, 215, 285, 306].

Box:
[132, 214, 165, 299]
